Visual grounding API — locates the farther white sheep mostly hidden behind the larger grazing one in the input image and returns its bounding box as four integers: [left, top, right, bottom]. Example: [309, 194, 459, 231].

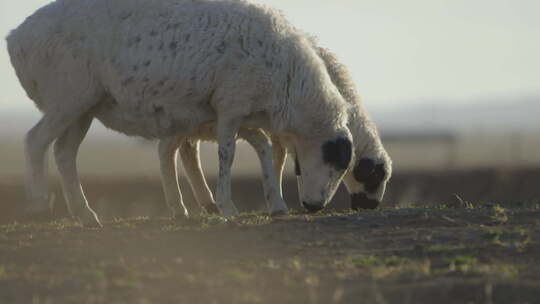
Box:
[170, 43, 392, 214]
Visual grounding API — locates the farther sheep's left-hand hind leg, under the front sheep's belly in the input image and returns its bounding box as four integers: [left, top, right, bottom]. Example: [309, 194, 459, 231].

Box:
[158, 137, 189, 219]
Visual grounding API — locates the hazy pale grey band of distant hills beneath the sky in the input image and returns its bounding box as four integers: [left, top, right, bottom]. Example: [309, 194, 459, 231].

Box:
[0, 95, 540, 138]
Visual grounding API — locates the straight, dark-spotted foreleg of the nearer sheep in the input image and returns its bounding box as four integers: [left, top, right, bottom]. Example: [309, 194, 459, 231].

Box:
[216, 119, 241, 217]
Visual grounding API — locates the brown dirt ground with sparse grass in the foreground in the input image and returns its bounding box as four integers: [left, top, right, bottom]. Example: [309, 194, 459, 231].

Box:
[0, 204, 540, 304]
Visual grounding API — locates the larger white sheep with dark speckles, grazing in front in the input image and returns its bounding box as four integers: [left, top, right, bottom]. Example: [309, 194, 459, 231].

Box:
[7, 0, 354, 226]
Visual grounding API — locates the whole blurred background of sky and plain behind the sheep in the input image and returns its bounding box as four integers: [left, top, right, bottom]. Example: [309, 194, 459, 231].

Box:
[0, 0, 540, 220]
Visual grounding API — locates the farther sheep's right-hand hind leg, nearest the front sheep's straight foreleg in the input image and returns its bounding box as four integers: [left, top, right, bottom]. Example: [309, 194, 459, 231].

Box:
[180, 140, 219, 214]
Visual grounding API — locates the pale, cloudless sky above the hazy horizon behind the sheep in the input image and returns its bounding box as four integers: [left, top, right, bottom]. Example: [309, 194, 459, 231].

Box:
[0, 0, 540, 113]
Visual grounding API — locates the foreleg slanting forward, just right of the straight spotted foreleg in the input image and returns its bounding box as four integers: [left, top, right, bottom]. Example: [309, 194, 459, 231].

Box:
[238, 129, 288, 215]
